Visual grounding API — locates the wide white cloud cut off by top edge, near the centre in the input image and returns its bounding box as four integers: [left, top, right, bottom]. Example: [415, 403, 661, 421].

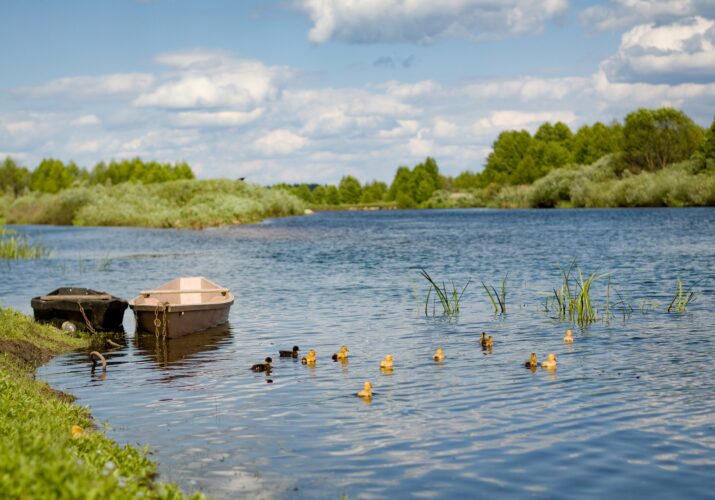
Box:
[296, 0, 568, 43]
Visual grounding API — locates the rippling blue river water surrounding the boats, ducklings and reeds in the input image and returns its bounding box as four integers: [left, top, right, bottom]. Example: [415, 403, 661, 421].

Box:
[0, 209, 715, 498]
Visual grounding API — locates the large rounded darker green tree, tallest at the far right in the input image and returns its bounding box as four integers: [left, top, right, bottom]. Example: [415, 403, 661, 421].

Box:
[623, 108, 703, 171]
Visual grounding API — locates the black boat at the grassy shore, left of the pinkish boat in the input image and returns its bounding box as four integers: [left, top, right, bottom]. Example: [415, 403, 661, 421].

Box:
[30, 287, 129, 332]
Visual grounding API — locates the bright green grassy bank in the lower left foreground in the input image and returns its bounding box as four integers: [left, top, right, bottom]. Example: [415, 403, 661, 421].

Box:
[0, 308, 201, 499]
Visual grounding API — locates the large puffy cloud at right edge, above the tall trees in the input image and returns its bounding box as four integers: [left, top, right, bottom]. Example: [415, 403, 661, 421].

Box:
[602, 17, 715, 84]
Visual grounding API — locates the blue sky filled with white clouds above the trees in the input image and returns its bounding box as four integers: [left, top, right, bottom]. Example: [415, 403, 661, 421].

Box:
[0, 0, 715, 184]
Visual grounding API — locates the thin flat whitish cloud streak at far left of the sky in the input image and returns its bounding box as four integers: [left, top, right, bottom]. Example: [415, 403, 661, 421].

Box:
[16, 73, 154, 98]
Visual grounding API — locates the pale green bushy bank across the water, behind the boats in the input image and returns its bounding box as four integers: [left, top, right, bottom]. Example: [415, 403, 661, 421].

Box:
[5, 179, 304, 228]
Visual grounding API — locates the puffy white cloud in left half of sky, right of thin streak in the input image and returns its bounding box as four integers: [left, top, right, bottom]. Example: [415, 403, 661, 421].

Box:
[134, 50, 290, 111]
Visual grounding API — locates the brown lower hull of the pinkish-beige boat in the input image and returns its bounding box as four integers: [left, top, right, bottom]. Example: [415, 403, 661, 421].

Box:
[131, 301, 233, 338]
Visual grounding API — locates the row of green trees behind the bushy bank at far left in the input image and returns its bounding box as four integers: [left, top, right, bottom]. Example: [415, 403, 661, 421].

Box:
[0, 157, 195, 196]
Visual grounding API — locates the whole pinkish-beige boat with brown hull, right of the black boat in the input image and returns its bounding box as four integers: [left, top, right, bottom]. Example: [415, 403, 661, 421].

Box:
[129, 276, 233, 338]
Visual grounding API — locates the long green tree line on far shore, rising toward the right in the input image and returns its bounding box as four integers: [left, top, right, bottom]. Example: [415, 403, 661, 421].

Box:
[274, 108, 715, 208]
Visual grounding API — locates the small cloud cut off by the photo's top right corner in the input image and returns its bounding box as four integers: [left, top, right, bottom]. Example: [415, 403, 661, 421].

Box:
[581, 0, 715, 30]
